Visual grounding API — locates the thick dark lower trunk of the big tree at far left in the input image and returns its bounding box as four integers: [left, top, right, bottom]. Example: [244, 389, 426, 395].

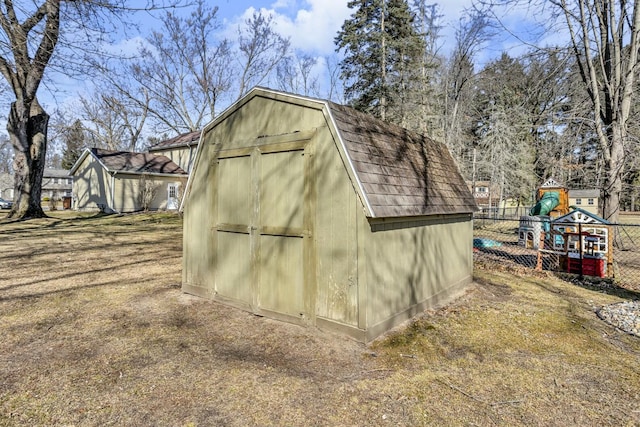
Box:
[7, 99, 49, 219]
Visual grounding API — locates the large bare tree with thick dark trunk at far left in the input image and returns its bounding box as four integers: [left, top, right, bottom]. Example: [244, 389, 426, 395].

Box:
[0, 0, 180, 218]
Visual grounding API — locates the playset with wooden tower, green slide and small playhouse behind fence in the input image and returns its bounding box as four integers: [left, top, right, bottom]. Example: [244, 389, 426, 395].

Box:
[518, 178, 613, 277]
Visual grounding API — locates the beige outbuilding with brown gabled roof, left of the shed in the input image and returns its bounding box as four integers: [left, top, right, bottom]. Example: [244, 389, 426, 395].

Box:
[69, 148, 187, 212]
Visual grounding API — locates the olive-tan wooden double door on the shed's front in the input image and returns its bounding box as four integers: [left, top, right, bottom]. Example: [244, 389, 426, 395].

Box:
[215, 143, 309, 318]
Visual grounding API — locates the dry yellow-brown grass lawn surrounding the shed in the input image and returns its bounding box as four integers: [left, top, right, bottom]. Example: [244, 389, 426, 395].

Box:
[0, 213, 640, 426]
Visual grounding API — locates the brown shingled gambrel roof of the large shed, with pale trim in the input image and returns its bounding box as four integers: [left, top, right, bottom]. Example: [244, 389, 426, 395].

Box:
[188, 87, 478, 218]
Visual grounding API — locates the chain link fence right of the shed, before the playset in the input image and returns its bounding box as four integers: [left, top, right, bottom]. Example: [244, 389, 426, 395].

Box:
[473, 216, 640, 290]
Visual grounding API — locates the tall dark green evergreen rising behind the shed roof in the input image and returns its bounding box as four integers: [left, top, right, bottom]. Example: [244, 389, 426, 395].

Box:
[335, 0, 424, 124]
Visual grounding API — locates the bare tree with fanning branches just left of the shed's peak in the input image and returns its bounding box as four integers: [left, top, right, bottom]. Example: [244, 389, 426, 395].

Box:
[107, 0, 233, 138]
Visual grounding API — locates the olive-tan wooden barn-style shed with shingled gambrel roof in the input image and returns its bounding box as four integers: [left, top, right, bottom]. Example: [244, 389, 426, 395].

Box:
[183, 88, 477, 342]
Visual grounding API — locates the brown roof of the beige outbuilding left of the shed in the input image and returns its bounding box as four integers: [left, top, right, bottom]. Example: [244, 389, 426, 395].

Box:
[69, 148, 187, 175]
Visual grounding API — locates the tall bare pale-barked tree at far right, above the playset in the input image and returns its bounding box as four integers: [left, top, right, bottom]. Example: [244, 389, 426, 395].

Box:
[481, 0, 640, 222]
